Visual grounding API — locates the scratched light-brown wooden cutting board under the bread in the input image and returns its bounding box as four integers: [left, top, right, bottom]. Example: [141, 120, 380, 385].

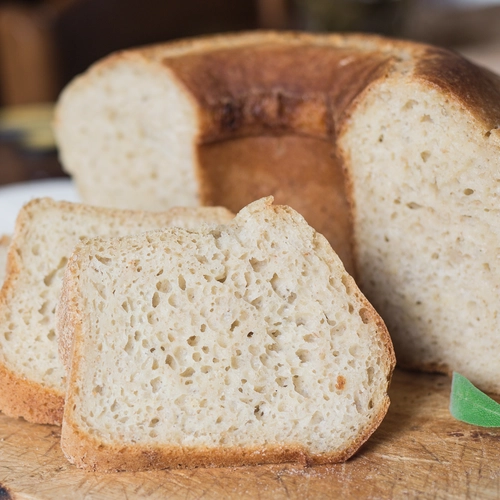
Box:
[0, 371, 500, 500]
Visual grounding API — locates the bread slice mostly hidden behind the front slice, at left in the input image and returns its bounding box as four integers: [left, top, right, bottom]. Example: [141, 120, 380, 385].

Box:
[0, 199, 232, 424]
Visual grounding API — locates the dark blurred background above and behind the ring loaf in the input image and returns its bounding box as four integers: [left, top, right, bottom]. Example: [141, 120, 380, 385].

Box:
[0, 0, 500, 187]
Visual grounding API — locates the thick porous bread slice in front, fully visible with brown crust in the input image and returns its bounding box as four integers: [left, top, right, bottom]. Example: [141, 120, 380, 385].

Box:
[58, 198, 395, 471]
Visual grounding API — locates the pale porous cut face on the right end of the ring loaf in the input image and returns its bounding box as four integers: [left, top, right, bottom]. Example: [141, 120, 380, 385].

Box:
[340, 74, 500, 393]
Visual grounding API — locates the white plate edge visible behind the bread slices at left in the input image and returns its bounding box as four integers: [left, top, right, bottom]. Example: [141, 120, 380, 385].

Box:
[0, 178, 80, 236]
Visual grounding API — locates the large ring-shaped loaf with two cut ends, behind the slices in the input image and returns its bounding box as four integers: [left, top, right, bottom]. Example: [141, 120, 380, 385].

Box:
[56, 32, 500, 392]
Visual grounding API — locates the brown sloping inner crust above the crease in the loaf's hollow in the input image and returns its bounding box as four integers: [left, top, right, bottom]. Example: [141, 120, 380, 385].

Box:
[162, 45, 392, 143]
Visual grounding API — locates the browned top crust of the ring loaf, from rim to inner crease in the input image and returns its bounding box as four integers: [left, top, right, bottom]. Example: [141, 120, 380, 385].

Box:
[95, 32, 500, 143]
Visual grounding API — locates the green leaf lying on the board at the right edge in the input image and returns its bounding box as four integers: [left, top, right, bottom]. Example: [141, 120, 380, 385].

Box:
[450, 372, 500, 427]
